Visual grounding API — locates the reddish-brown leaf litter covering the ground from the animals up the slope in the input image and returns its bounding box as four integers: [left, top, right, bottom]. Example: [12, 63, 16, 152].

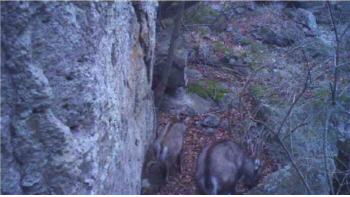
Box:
[153, 3, 292, 195]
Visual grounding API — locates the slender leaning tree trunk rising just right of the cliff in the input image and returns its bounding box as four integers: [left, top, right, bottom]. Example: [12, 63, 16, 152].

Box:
[154, 1, 185, 105]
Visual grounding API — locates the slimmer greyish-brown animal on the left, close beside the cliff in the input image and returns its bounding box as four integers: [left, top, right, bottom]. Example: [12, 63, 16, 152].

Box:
[154, 117, 186, 182]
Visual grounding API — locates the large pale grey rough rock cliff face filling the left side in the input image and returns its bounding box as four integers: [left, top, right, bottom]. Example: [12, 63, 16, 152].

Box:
[1, 2, 157, 194]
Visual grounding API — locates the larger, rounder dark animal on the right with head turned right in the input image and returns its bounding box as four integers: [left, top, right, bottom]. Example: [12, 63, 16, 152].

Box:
[195, 140, 260, 195]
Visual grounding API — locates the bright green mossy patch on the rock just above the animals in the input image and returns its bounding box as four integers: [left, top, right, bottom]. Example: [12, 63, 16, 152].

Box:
[187, 79, 229, 102]
